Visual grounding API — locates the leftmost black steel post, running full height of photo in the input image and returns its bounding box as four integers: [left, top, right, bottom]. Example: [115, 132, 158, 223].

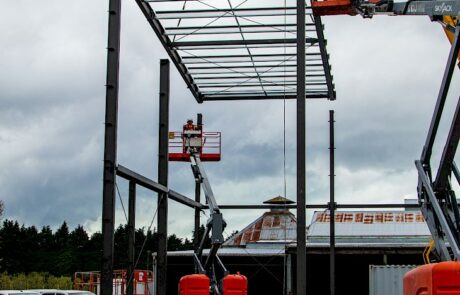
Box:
[101, 0, 121, 295]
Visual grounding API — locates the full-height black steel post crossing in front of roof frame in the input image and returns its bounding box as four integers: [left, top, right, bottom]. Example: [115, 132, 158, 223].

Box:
[296, 0, 307, 295]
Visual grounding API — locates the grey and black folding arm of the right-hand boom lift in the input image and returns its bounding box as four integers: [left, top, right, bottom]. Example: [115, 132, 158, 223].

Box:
[415, 27, 460, 261]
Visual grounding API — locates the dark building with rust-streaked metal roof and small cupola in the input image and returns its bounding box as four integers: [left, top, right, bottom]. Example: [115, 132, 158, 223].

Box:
[164, 197, 431, 295]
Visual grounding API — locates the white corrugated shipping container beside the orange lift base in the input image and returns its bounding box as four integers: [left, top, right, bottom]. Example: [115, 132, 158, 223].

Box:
[369, 265, 417, 295]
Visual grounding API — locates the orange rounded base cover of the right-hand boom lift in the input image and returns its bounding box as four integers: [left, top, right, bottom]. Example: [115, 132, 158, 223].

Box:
[404, 261, 460, 295]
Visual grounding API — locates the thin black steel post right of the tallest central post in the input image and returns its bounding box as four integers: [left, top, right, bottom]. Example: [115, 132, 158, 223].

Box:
[329, 110, 335, 295]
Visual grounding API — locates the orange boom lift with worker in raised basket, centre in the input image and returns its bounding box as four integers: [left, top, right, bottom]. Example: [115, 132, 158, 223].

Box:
[169, 114, 247, 295]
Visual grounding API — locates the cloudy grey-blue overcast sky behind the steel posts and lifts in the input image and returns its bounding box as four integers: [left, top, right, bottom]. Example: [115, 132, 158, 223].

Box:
[0, 0, 460, 236]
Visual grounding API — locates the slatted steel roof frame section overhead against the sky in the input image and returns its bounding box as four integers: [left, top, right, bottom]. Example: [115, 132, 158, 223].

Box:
[136, 0, 335, 103]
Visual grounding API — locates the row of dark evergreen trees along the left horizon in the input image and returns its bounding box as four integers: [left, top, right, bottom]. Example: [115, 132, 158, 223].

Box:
[0, 219, 210, 276]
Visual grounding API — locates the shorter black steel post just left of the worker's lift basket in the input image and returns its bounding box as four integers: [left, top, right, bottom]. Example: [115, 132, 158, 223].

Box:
[156, 59, 169, 295]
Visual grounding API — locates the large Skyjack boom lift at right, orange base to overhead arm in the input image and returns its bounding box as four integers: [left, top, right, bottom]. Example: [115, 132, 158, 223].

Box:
[312, 0, 460, 295]
